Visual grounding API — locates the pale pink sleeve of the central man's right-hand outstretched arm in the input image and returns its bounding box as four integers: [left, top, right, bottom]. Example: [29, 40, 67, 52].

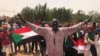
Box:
[63, 22, 84, 36]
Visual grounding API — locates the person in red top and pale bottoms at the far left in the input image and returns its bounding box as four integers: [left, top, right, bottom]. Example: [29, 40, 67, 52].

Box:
[0, 24, 13, 56]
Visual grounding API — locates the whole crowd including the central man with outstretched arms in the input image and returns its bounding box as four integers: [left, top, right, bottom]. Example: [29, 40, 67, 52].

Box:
[0, 15, 100, 56]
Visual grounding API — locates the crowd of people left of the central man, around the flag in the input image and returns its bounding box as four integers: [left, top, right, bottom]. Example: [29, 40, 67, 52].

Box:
[0, 19, 46, 56]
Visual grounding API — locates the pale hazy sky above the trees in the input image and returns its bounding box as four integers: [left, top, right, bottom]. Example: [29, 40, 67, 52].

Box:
[0, 0, 100, 16]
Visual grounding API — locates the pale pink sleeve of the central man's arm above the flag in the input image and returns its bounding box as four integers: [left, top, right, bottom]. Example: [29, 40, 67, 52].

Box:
[27, 22, 46, 36]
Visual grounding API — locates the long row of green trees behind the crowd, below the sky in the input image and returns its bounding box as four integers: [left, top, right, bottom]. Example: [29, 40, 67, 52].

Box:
[17, 4, 100, 22]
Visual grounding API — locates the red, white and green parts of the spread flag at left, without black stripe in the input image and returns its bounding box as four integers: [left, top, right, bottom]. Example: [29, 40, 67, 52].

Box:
[11, 26, 38, 44]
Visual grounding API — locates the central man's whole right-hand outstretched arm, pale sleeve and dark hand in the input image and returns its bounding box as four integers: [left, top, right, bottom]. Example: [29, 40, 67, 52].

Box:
[63, 16, 92, 36]
